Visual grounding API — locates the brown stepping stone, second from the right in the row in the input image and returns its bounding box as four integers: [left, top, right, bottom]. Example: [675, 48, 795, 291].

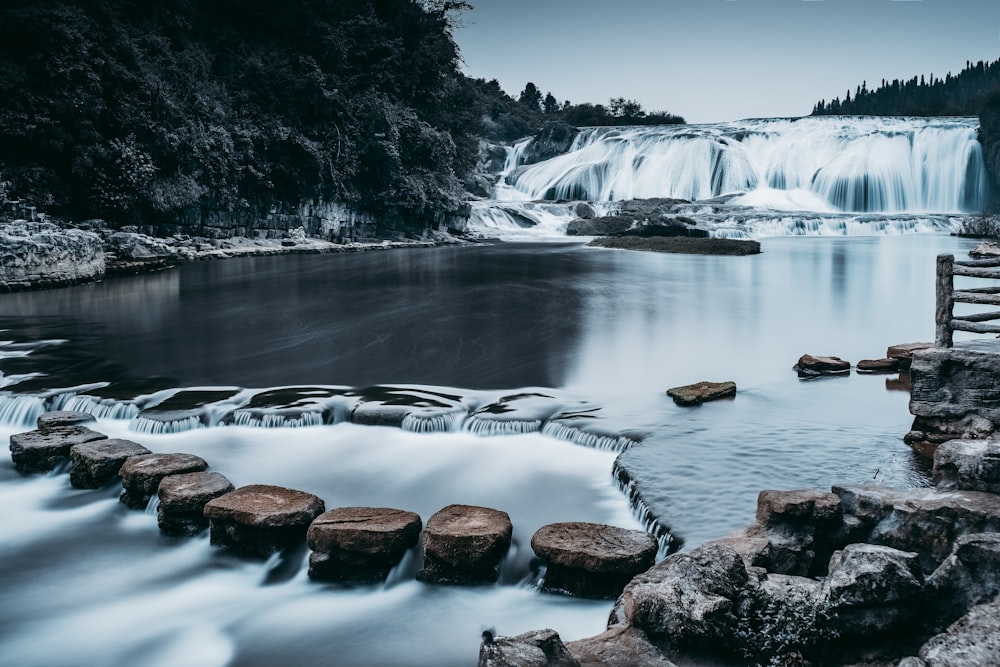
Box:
[417, 505, 514, 585]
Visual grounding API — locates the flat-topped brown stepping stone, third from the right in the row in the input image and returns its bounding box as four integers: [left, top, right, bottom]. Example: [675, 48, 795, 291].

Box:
[307, 507, 423, 584]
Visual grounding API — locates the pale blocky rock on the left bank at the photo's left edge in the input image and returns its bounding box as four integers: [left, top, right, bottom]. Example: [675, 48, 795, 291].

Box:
[0, 222, 105, 292]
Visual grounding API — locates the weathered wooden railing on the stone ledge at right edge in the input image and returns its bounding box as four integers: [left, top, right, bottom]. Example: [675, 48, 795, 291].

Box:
[934, 255, 1000, 347]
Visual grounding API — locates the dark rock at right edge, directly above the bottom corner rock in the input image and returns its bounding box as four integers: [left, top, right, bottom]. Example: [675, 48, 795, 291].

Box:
[927, 533, 1000, 627]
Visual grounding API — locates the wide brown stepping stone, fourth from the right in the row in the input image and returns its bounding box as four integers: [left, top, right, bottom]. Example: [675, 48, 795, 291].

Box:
[205, 484, 326, 558]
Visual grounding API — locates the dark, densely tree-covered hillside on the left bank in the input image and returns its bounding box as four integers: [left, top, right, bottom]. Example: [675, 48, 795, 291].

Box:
[0, 0, 479, 230]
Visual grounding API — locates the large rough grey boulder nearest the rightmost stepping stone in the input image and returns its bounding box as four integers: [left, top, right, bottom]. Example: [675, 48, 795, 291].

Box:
[622, 543, 748, 646]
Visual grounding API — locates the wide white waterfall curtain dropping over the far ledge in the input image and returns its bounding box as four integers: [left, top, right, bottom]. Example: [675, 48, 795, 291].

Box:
[504, 117, 987, 213]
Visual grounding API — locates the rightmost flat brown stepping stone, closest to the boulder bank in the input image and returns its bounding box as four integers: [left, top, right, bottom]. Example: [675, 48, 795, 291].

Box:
[531, 522, 658, 599]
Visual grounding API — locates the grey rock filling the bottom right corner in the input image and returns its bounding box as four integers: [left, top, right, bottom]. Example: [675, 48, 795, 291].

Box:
[920, 600, 1000, 667]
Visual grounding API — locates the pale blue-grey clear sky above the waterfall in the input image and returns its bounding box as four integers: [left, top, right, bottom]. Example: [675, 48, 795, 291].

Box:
[454, 0, 1000, 123]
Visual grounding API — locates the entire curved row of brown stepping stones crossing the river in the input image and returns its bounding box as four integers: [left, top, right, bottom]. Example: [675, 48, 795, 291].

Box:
[10, 412, 658, 598]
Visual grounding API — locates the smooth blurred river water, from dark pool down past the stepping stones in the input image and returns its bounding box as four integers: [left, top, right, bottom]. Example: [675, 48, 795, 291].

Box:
[0, 234, 984, 667]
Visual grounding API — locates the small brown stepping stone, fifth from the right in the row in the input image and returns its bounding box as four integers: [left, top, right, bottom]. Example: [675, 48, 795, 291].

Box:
[156, 472, 236, 535]
